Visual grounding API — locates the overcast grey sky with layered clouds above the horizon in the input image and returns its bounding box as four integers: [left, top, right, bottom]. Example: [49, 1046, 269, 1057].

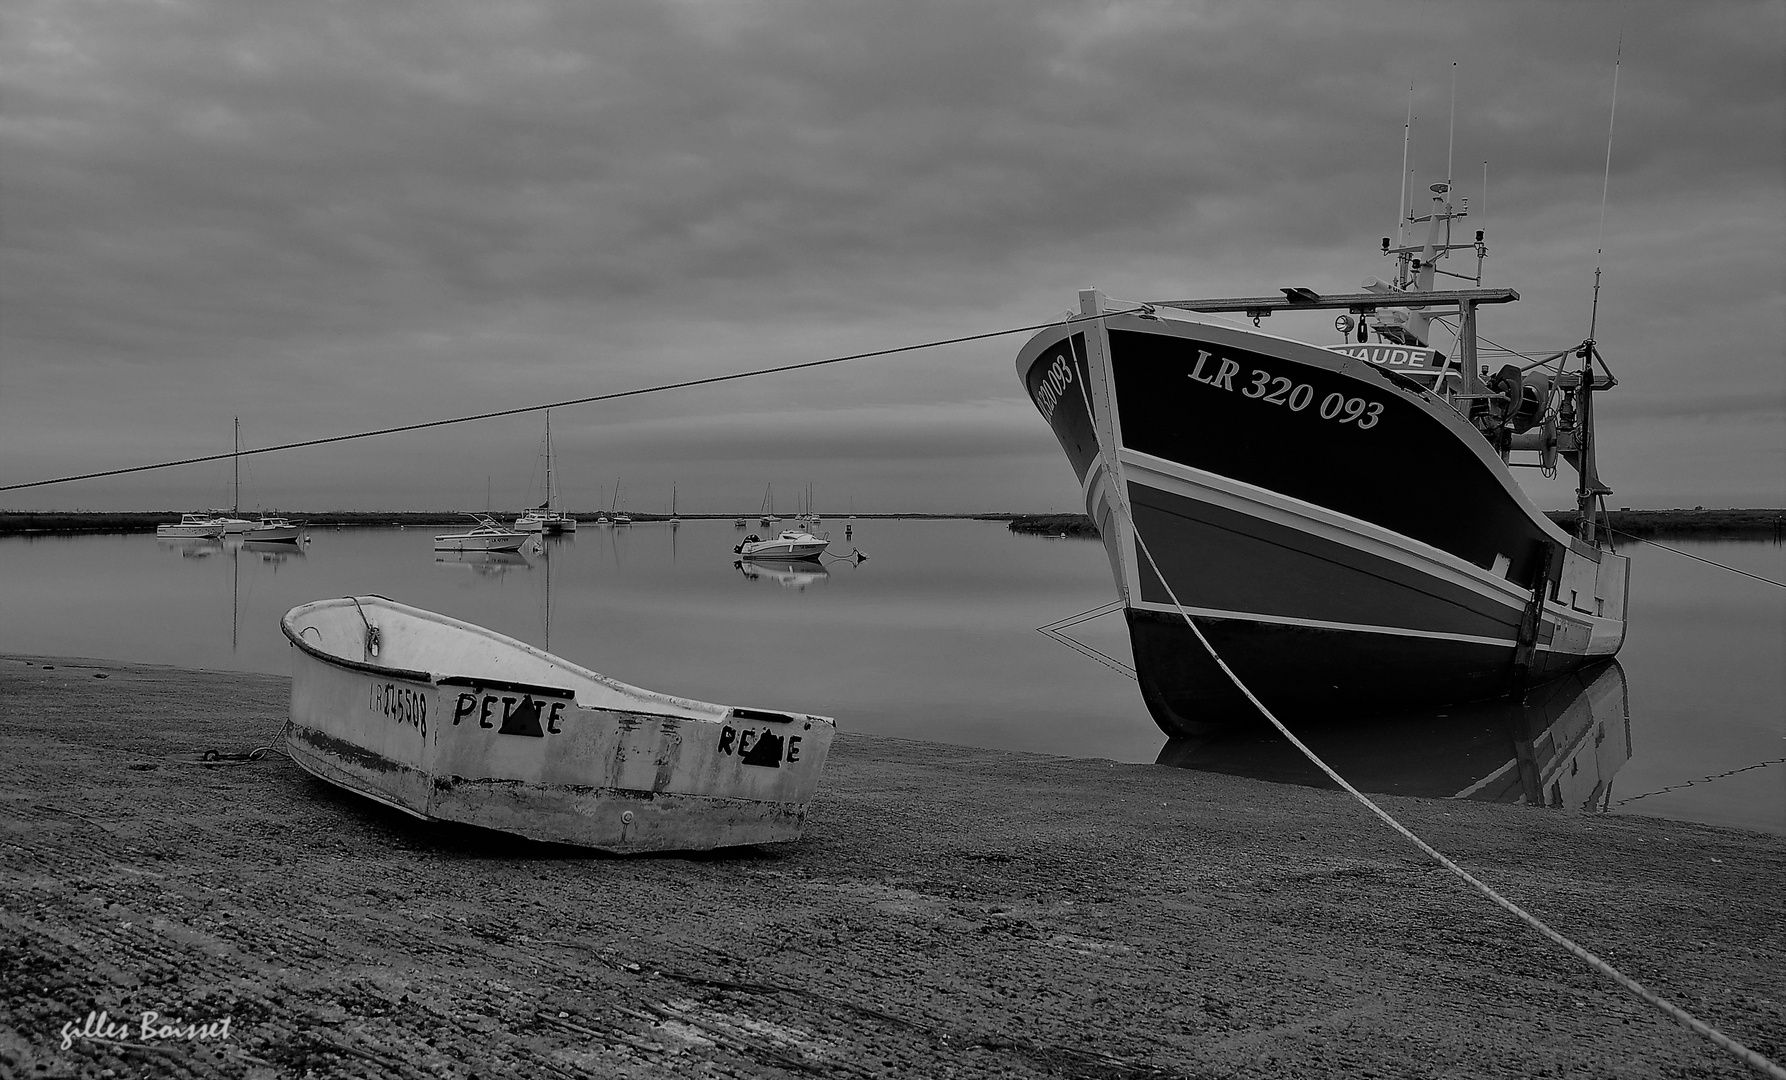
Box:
[0, 0, 1786, 514]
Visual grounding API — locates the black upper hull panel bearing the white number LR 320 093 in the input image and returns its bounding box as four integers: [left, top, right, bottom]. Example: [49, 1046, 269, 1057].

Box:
[1109, 320, 1566, 584]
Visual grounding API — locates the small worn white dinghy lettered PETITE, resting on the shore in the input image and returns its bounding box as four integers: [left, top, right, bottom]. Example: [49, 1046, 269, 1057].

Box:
[280, 596, 836, 852]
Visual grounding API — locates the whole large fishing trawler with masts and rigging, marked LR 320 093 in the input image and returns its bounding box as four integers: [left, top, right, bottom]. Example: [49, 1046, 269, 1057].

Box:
[1016, 182, 1629, 735]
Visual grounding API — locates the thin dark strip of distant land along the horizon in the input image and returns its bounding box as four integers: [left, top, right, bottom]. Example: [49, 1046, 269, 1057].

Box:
[0, 509, 1786, 539]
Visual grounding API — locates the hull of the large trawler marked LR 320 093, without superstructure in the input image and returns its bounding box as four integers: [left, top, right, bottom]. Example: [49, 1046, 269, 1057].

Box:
[1018, 314, 1627, 735]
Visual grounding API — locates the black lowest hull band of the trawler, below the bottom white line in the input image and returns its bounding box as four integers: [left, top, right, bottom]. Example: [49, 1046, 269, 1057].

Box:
[1125, 609, 1591, 737]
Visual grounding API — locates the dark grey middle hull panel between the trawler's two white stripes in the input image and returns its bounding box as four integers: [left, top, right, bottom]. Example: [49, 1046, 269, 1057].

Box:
[1127, 482, 1520, 644]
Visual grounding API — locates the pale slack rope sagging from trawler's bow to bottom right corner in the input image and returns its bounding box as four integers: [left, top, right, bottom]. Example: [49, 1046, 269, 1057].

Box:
[1079, 355, 1786, 1080]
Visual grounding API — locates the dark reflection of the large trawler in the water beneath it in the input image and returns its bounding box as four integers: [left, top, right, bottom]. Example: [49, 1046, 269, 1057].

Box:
[1159, 660, 1631, 810]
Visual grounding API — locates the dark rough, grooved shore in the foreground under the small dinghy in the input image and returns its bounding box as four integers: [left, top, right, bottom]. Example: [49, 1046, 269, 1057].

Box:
[0, 657, 1786, 1078]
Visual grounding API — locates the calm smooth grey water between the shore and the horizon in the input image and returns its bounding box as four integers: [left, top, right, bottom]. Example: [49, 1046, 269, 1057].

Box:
[0, 519, 1786, 834]
